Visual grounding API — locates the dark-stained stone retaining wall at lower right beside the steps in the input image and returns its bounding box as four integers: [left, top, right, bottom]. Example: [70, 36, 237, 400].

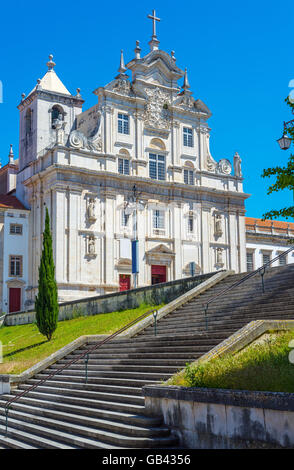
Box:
[143, 386, 294, 449]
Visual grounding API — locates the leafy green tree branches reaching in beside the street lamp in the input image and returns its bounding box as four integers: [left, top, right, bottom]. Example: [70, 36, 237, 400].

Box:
[261, 98, 294, 219]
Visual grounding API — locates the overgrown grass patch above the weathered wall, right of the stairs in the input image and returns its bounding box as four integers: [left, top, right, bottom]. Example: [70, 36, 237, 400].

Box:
[168, 331, 294, 393]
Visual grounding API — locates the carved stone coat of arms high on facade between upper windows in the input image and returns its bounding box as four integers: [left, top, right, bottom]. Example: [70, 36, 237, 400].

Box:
[145, 87, 171, 129]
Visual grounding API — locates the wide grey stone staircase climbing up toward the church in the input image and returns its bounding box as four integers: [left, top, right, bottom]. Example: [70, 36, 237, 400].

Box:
[0, 265, 294, 449]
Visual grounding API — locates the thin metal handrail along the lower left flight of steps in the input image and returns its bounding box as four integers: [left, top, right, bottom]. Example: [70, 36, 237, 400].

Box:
[4, 309, 157, 434]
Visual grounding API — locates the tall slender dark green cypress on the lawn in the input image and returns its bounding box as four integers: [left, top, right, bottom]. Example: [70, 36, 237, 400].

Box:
[35, 207, 58, 341]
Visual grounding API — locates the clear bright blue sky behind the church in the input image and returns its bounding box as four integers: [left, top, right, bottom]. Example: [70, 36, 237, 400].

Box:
[0, 0, 294, 217]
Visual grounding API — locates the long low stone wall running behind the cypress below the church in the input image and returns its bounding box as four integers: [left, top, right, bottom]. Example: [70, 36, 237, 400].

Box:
[5, 273, 215, 326]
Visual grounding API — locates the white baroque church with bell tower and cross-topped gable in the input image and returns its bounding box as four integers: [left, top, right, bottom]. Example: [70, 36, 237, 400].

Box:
[3, 12, 248, 308]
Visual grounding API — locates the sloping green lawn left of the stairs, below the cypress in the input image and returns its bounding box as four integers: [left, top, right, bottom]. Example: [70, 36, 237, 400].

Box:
[0, 305, 162, 374]
